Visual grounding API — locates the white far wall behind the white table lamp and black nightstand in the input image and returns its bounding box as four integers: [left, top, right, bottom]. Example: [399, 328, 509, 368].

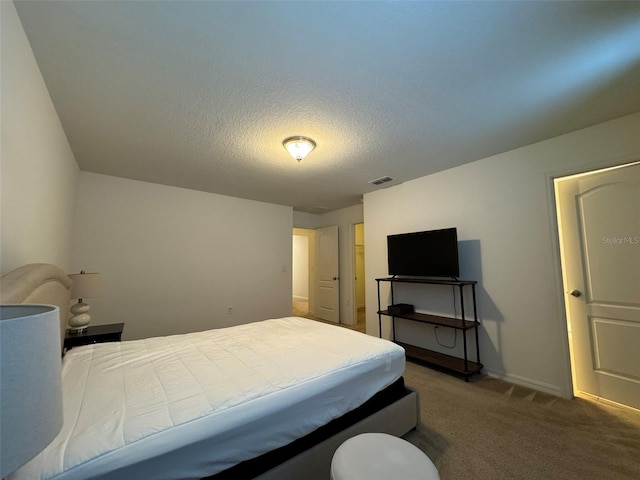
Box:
[72, 172, 293, 340]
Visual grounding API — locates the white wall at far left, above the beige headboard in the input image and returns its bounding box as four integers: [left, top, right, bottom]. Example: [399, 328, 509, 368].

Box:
[0, 1, 78, 274]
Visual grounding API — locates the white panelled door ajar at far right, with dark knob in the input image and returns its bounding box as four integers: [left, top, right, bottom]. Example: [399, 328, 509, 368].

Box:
[556, 164, 640, 409]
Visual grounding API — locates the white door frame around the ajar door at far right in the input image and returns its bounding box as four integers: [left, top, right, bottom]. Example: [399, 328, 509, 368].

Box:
[545, 155, 640, 402]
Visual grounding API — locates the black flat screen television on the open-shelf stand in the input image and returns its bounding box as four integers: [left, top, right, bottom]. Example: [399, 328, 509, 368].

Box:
[387, 228, 460, 278]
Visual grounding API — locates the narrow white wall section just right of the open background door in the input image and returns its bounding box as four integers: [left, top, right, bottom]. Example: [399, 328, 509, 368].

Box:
[318, 205, 364, 325]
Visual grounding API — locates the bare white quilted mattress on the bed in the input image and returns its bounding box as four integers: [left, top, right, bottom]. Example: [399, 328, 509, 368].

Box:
[10, 317, 405, 480]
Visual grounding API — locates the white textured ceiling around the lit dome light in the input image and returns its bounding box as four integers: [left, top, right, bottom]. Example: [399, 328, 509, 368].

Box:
[15, 1, 640, 213]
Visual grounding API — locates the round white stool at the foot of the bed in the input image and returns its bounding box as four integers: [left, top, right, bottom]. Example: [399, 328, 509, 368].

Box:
[331, 433, 440, 480]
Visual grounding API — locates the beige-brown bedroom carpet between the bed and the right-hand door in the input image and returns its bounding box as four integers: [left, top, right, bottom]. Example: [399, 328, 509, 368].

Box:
[405, 362, 640, 480]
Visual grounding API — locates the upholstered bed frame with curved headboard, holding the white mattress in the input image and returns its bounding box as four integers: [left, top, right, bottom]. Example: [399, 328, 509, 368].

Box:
[0, 263, 419, 480]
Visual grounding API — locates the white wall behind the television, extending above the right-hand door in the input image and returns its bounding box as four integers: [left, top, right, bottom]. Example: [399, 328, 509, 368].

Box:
[364, 113, 640, 396]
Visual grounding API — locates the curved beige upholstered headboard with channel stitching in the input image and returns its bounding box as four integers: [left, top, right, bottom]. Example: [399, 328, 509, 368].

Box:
[0, 263, 73, 350]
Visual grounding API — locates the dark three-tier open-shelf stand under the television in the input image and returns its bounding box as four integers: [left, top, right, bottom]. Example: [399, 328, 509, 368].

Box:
[376, 276, 482, 381]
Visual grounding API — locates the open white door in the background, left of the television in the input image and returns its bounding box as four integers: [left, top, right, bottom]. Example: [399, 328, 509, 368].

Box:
[315, 225, 340, 323]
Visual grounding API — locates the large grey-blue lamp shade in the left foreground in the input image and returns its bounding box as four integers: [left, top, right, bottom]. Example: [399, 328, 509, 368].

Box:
[0, 305, 62, 478]
